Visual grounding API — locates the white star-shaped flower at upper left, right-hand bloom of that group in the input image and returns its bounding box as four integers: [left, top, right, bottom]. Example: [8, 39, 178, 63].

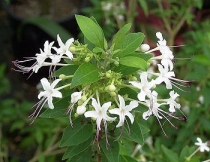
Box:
[53, 35, 74, 60]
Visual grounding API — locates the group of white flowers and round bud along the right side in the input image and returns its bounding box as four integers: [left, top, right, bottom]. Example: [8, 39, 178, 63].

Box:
[129, 32, 190, 135]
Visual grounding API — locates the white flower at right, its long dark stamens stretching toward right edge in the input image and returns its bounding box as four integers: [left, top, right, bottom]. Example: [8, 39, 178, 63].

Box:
[155, 64, 175, 89]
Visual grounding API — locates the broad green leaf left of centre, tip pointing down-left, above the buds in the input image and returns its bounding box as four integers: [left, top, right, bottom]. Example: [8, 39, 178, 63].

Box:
[71, 63, 99, 88]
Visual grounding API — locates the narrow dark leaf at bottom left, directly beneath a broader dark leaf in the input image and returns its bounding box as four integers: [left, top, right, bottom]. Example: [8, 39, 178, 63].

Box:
[62, 137, 93, 160]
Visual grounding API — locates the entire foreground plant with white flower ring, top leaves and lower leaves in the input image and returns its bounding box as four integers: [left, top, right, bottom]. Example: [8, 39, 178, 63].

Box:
[13, 15, 189, 162]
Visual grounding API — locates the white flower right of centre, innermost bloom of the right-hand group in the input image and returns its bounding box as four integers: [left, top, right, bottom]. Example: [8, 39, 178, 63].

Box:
[129, 72, 154, 101]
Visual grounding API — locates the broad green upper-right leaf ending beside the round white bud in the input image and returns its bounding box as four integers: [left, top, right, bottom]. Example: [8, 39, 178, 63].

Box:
[114, 33, 144, 57]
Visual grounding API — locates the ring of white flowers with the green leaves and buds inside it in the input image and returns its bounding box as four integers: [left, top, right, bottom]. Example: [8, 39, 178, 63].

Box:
[13, 16, 189, 146]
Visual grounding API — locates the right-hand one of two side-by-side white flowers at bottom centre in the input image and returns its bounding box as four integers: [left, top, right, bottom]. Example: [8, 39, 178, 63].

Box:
[109, 95, 138, 127]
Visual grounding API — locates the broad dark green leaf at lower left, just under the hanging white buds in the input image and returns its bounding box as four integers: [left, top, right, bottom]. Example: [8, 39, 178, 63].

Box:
[60, 118, 93, 147]
